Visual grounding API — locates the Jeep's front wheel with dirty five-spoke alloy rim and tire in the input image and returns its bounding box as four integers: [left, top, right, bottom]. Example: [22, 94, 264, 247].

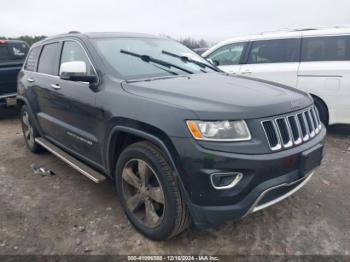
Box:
[116, 142, 190, 240]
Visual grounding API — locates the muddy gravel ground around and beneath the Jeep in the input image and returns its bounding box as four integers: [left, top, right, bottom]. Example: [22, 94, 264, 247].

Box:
[0, 107, 350, 255]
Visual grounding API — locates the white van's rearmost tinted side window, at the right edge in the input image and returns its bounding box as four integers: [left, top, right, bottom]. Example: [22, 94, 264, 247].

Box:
[301, 36, 350, 61]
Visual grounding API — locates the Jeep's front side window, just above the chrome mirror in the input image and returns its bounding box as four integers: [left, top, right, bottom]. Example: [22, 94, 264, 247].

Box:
[60, 41, 95, 75]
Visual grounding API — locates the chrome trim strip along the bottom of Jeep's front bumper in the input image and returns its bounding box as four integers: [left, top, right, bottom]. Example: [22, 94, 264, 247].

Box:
[245, 172, 314, 216]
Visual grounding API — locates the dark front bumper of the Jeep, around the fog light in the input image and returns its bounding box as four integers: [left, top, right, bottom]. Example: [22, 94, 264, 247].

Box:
[173, 128, 326, 227]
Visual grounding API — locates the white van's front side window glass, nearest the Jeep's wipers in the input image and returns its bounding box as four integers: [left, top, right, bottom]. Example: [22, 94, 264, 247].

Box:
[207, 43, 245, 66]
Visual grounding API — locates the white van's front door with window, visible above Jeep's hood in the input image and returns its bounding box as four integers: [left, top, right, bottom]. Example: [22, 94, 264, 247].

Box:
[206, 42, 247, 74]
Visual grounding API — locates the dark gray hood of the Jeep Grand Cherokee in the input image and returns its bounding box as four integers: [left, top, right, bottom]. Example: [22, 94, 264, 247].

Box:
[122, 73, 313, 120]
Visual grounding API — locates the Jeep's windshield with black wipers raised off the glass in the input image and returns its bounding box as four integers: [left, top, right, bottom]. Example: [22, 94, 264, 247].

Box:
[94, 38, 214, 80]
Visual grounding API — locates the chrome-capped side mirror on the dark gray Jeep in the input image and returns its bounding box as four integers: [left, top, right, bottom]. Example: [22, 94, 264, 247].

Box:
[60, 61, 97, 84]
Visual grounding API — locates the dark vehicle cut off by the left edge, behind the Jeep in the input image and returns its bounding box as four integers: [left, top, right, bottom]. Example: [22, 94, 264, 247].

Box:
[0, 39, 29, 108]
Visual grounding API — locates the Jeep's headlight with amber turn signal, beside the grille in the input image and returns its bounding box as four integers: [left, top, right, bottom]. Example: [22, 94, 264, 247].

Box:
[186, 120, 251, 141]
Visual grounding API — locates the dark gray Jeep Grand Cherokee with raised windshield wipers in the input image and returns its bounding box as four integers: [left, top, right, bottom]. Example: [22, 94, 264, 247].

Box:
[18, 32, 326, 240]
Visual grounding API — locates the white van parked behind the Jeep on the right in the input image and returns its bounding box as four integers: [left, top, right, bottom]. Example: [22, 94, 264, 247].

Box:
[203, 27, 350, 125]
